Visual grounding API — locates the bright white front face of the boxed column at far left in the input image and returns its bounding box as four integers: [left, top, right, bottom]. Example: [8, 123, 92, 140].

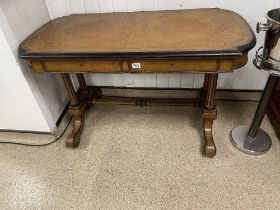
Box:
[0, 19, 49, 131]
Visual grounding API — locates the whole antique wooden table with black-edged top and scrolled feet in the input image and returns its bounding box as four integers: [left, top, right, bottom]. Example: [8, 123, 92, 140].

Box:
[19, 9, 256, 156]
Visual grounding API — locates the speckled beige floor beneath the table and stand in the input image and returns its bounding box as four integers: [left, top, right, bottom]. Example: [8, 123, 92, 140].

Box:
[0, 101, 280, 210]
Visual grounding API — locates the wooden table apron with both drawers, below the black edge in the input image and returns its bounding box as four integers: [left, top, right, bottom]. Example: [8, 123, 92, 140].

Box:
[28, 54, 247, 73]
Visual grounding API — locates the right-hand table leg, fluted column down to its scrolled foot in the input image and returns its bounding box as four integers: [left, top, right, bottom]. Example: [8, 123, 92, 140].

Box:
[202, 74, 218, 157]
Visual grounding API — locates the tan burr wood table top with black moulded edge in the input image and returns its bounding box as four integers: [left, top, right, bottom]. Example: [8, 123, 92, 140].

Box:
[19, 9, 256, 59]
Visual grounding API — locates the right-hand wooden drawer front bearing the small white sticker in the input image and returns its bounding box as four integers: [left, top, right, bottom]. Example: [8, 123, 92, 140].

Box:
[128, 59, 219, 73]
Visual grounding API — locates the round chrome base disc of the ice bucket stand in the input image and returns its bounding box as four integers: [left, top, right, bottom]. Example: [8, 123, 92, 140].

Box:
[230, 125, 272, 155]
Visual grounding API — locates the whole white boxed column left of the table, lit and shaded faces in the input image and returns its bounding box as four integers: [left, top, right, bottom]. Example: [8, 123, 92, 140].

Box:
[0, 0, 67, 132]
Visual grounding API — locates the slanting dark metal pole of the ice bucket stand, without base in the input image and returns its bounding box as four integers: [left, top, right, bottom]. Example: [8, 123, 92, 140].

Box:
[248, 75, 278, 139]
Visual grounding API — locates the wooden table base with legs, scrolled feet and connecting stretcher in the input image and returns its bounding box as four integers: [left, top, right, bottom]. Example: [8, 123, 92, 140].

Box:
[62, 73, 218, 157]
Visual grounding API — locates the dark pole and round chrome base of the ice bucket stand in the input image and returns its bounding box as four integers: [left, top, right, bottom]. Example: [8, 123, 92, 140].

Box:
[231, 75, 278, 155]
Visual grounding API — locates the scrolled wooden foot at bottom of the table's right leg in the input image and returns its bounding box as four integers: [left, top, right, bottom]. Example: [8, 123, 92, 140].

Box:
[202, 110, 217, 157]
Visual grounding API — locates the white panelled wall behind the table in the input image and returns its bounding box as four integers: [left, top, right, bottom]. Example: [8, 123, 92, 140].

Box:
[45, 0, 280, 90]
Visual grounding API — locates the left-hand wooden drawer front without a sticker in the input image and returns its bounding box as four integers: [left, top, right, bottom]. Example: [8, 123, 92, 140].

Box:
[30, 60, 122, 73]
